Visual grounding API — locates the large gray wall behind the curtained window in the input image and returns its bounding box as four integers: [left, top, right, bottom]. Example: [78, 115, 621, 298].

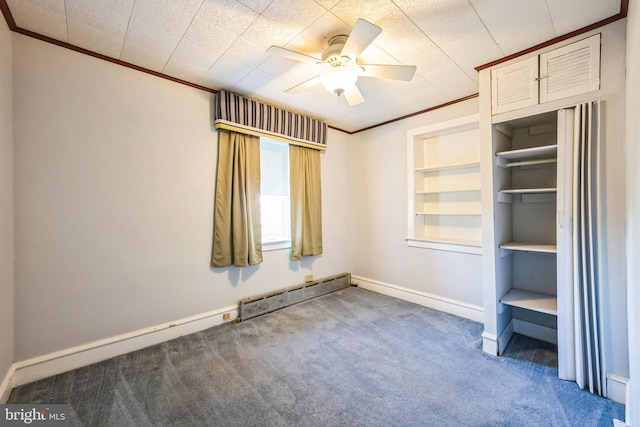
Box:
[13, 34, 352, 360]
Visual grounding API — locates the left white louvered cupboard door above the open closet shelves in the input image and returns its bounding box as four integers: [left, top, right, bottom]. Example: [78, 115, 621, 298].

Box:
[491, 56, 538, 114]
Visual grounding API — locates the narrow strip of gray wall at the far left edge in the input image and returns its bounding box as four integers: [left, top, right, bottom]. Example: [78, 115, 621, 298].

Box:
[0, 18, 14, 390]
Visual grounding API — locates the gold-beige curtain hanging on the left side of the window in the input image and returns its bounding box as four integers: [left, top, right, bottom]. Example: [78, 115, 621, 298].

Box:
[211, 130, 262, 267]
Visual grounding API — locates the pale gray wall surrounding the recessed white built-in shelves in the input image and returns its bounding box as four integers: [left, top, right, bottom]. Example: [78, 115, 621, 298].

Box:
[352, 98, 482, 307]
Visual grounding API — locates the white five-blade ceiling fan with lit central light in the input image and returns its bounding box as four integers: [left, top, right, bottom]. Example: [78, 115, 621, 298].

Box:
[267, 19, 416, 106]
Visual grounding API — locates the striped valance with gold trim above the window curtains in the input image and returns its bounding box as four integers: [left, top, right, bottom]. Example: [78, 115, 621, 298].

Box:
[214, 90, 327, 150]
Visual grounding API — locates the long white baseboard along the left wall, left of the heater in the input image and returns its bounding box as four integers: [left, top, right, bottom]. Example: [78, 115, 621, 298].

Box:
[9, 305, 238, 397]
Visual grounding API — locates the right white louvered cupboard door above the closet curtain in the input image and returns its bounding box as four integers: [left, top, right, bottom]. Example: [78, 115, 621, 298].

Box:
[540, 34, 600, 103]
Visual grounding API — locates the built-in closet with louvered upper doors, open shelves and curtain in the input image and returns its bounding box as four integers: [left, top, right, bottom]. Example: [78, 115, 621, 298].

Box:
[478, 20, 634, 402]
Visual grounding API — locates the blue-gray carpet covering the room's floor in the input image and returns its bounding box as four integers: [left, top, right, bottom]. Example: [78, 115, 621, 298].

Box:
[9, 288, 624, 427]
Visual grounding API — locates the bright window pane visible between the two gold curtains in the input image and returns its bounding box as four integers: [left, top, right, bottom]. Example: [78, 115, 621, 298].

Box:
[260, 138, 291, 251]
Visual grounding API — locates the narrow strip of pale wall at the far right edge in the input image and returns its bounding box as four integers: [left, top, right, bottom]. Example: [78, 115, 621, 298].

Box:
[625, 1, 640, 425]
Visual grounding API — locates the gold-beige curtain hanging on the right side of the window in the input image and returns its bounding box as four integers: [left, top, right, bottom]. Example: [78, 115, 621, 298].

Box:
[289, 145, 322, 261]
